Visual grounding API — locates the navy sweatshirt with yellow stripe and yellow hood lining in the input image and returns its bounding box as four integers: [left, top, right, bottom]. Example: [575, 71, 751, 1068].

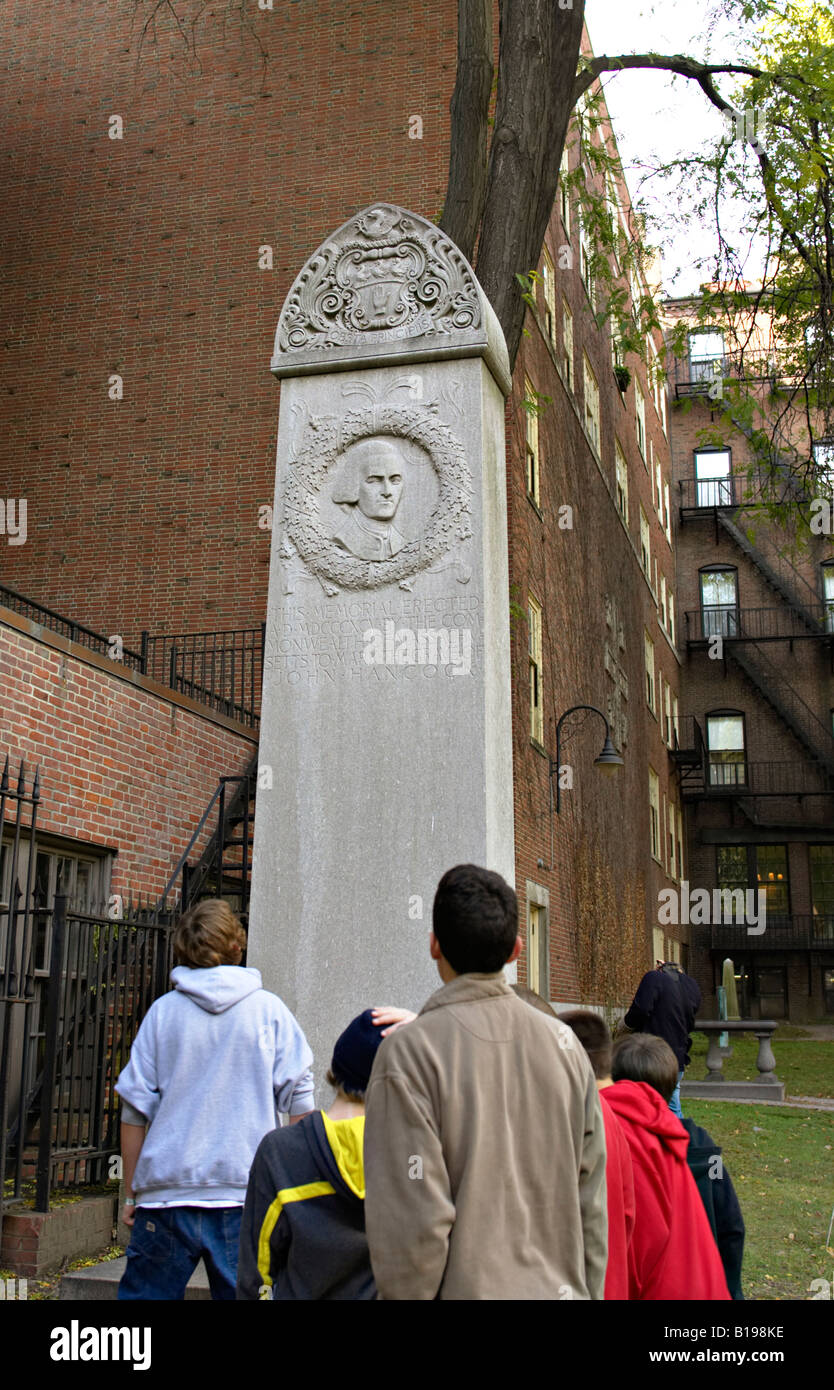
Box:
[238, 1111, 377, 1300]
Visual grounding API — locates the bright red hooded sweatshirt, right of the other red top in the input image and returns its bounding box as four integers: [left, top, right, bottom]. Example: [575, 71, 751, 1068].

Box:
[602, 1081, 730, 1300]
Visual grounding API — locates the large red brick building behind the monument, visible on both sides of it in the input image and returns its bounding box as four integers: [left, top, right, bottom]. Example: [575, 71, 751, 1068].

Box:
[0, 0, 688, 1023]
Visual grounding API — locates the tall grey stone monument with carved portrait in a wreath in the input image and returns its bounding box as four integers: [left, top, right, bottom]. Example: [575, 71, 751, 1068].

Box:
[249, 203, 513, 1083]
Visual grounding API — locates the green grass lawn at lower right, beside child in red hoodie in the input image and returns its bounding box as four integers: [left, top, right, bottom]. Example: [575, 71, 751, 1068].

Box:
[684, 1095, 834, 1300]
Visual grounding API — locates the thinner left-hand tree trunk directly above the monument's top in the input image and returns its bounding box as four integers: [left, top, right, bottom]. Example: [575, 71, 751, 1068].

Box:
[441, 0, 492, 261]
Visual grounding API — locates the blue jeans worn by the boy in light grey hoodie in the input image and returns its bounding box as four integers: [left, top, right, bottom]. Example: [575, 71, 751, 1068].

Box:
[118, 1207, 243, 1302]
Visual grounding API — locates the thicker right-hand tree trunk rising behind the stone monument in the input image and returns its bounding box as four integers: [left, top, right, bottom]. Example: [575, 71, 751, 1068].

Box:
[475, 0, 585, 366]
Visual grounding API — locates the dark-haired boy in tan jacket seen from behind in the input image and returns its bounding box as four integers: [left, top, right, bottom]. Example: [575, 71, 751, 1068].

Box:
[364, 865, 607, 1300]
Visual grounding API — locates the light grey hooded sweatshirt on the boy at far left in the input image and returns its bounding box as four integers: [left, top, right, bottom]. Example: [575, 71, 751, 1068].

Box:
[115, 965, 313, 1207]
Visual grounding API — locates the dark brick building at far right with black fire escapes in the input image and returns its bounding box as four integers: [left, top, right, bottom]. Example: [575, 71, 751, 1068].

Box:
[667, 300, 834, 1020]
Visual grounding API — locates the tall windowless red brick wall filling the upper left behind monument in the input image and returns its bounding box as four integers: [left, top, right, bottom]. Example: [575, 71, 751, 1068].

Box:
[0, 0, 456, 644]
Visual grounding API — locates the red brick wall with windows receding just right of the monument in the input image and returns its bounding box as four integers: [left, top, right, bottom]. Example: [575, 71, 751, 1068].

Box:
[507, 84, 687, 1002]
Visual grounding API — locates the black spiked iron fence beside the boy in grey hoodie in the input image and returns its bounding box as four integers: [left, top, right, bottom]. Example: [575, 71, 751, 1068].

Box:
[0, 758, 174, 1229]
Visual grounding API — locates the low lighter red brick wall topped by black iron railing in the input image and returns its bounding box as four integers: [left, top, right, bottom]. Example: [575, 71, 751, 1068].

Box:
[0, 623, 254, 897]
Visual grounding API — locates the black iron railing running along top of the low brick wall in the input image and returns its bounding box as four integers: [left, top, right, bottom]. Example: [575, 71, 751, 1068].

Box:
[0, 585, 265, 728]
